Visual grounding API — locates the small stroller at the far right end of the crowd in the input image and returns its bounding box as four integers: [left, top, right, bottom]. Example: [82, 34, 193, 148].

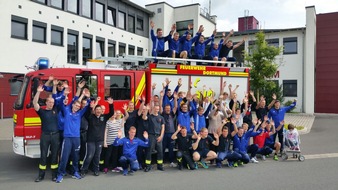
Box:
[282, 129, 305, 162]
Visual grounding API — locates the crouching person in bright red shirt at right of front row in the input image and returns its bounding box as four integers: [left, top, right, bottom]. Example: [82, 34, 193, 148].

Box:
[253, 117, 283, 160]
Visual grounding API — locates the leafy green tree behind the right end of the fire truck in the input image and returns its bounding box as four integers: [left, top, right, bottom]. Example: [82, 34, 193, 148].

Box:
[244, 31, 282, 100]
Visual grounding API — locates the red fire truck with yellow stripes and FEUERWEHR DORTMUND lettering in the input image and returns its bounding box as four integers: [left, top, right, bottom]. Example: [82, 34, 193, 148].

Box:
[13, 60, 249, 158]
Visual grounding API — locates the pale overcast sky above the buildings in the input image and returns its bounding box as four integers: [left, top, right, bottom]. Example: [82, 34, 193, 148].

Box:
[131, 0, 338, 31]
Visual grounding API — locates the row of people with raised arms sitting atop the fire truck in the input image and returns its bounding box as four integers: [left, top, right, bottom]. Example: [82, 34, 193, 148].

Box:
[150, 21, 247, 66]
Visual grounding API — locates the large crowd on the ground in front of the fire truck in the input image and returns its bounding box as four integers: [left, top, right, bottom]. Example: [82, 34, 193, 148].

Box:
[33, 76, 299, 183]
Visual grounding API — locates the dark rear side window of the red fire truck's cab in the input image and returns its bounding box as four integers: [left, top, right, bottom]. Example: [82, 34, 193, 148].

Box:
[104, 75, 131, 100]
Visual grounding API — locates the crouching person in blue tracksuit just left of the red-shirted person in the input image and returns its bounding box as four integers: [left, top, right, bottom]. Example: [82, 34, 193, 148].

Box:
[233, 123, 263, 167]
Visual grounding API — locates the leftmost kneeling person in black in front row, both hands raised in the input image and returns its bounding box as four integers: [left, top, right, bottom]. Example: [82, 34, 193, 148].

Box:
[171, 123, 197, 170]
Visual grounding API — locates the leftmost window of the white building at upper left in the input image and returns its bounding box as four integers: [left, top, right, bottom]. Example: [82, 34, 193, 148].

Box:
[11, 15, 28, 39]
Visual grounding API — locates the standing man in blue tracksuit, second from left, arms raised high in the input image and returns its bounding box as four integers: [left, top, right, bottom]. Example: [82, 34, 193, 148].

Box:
[56, 81, 90, 183]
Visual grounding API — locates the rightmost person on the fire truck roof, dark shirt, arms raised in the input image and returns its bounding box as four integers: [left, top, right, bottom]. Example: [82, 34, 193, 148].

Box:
[219, 30, 247, 67]
